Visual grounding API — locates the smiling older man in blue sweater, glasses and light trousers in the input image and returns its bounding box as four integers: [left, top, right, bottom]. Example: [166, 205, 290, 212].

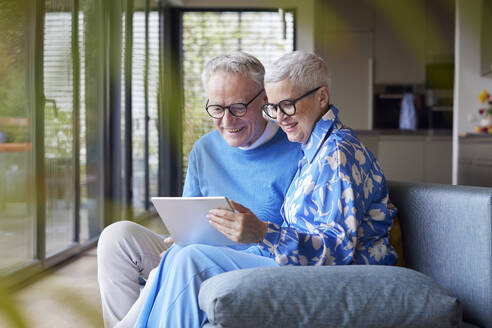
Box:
[97, 52, 300, 327]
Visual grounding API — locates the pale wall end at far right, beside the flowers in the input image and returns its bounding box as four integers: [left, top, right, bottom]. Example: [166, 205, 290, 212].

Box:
[453, 0, 492, 184]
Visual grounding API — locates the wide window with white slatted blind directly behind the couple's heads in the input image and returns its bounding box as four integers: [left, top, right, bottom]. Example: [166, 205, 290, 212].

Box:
[182, 11, 294, 176]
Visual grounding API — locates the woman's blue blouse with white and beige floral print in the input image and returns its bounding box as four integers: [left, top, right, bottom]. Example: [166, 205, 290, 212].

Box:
[259, 106, 397, 265]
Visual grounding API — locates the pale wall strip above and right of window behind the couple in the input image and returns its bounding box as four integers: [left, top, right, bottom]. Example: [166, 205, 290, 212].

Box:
[179, 0, 314, 51]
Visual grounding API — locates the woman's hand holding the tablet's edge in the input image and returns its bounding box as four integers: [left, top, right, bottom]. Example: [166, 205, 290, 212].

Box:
[207, 201, 268, 244]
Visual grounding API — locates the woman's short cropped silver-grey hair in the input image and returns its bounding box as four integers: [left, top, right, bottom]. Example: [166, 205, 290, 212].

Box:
[265, 50, 330, 91]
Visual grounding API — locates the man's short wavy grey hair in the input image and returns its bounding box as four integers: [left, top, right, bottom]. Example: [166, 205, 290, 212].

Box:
[202, 51, 265, 90]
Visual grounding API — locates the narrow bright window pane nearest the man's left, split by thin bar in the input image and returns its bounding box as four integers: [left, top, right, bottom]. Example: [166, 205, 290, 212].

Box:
[131, 11, 160, 215]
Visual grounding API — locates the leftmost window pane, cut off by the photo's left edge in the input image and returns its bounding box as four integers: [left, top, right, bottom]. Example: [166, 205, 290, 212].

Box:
[0, 0, 36, 272]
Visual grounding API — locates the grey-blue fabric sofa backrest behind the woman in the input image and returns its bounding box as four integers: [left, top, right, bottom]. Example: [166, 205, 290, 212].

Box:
[388, 181, 492, 327]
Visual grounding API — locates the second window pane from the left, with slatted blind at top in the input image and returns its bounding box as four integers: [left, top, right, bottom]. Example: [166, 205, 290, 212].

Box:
[43, 0, 75, 255]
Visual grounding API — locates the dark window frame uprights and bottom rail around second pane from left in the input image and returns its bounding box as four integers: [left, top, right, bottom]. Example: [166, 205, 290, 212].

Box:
[3, 0, 97, 288]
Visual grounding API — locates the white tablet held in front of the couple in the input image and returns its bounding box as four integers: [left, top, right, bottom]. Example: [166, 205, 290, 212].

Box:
[152, 197, 243, 246]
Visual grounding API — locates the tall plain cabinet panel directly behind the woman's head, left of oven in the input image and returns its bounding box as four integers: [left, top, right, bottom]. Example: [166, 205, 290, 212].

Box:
[315, 0, 374, 129]
